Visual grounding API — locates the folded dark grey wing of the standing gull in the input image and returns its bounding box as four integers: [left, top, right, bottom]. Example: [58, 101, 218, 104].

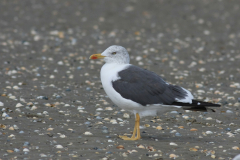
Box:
[112, 65, 187, 106]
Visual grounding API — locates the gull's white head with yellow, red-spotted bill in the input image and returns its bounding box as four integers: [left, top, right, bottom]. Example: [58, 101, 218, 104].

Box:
[90, 45, 130, 64]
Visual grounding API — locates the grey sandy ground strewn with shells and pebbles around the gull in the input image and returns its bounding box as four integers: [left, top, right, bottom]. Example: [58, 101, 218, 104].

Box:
[0, 0, 240, 160]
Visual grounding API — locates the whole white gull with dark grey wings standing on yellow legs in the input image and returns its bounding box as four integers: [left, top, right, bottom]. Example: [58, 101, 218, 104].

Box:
[90, 45, 220, 140]
